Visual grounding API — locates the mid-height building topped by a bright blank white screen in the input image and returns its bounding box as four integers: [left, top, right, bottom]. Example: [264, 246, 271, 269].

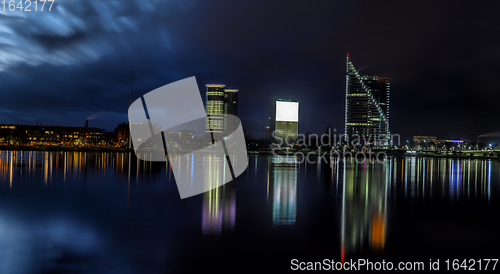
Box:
[270, 98, 299, 145]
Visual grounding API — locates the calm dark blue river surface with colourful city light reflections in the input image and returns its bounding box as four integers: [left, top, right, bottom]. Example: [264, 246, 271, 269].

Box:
[0, 151, 500, 273]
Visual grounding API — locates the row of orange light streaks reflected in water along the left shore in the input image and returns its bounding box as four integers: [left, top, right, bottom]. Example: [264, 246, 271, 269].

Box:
[0, 150, 165, 188]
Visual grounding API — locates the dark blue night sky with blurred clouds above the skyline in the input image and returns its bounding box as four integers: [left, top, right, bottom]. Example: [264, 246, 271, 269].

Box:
[0, 0, 500, 140]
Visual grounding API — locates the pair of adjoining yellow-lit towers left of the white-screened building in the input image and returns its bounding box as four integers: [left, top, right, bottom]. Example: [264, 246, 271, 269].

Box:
[206, 84, 238, 135]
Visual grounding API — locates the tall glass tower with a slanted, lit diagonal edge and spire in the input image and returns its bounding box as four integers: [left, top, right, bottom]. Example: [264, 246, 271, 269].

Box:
[345, 55, 390, 146]
